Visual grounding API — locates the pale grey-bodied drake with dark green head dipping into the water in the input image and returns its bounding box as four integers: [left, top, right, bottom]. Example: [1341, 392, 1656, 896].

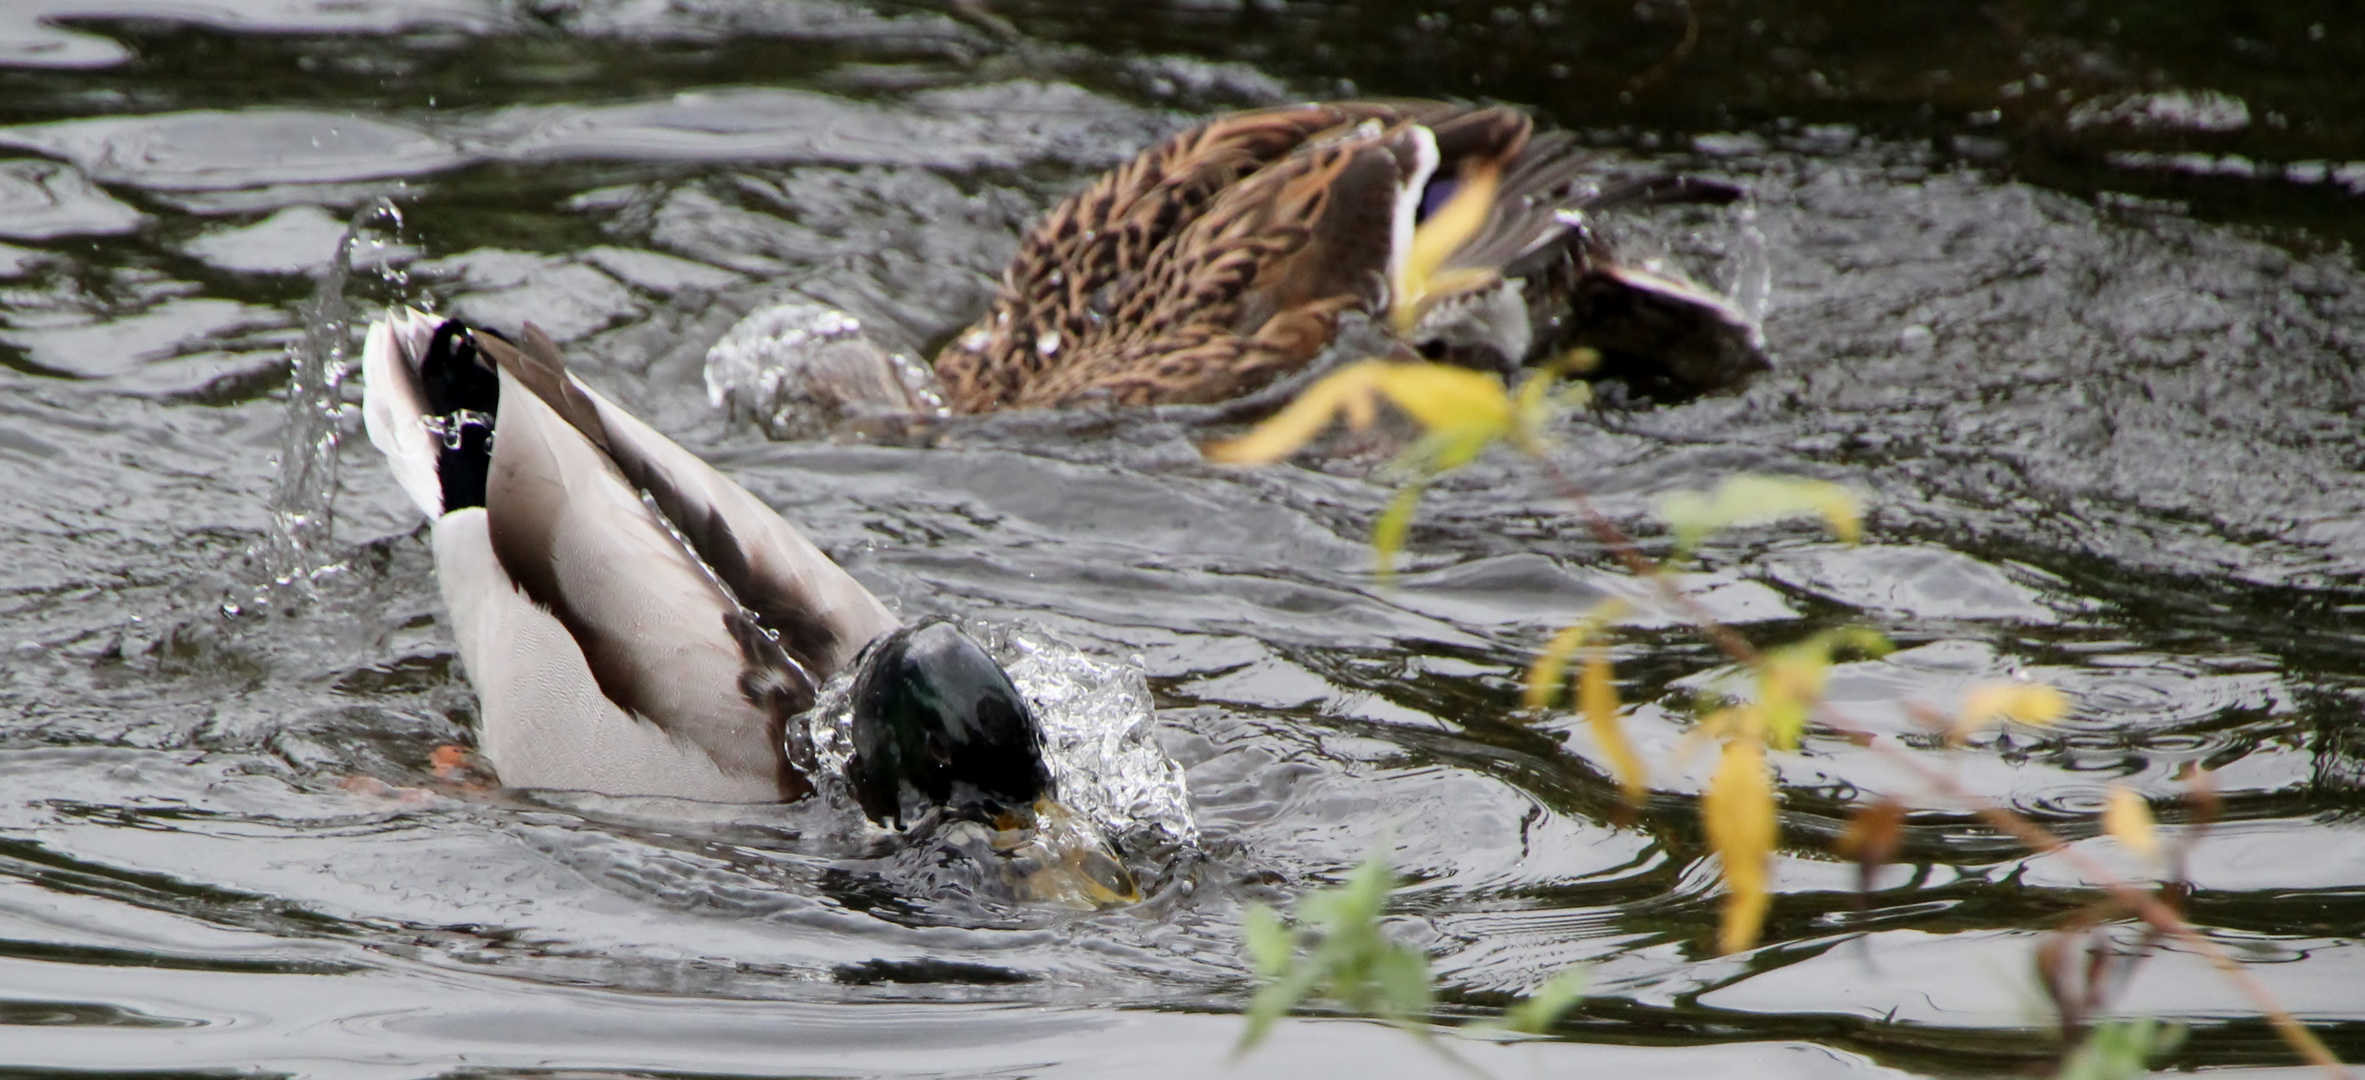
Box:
[362, 310, 1133, 900]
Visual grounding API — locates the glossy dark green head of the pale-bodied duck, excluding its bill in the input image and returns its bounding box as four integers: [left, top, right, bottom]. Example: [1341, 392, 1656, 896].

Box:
[847, 622, 1052, 825]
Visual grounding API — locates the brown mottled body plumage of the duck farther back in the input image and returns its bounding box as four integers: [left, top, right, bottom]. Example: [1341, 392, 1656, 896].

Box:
[937, 102, 1762, 411]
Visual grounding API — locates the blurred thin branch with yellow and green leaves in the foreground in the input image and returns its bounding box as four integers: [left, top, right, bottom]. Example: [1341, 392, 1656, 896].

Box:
[1206, 352, 2346, 1080]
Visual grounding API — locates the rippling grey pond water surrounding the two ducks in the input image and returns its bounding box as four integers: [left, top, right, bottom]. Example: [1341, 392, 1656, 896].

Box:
[0, 0, 2365, 1078]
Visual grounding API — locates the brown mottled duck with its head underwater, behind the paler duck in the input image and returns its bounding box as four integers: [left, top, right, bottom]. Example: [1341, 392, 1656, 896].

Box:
[937, 102, 1764, 411]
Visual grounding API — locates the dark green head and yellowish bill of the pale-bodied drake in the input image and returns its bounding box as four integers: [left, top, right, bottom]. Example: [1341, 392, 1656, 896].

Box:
[847, 622, 1140, 907]
